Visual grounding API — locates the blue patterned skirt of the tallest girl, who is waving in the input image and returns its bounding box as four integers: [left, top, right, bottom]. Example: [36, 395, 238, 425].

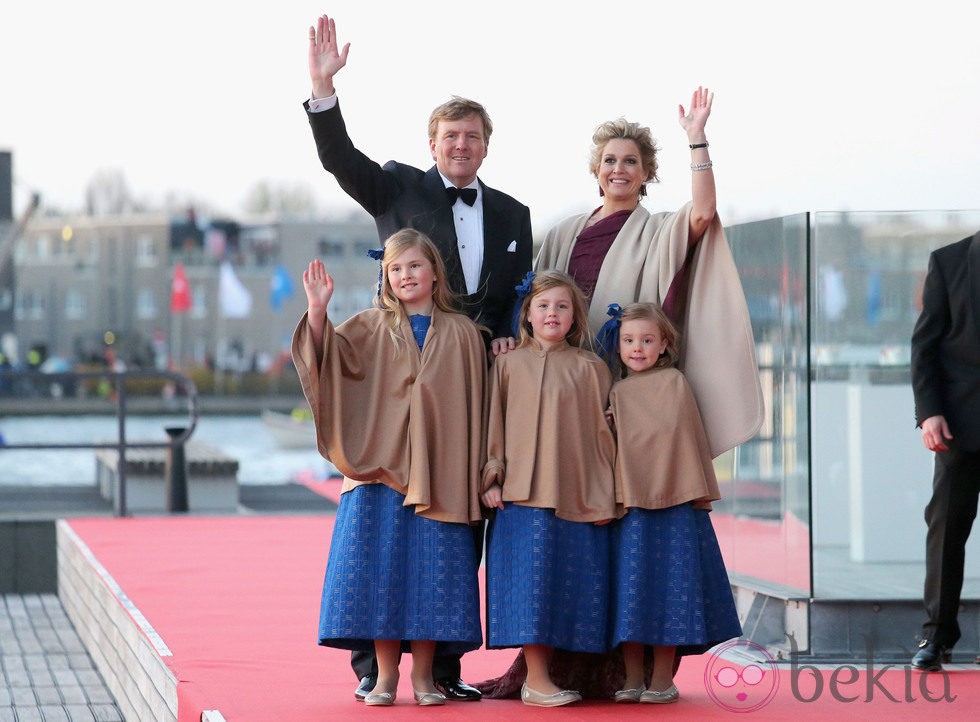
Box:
[318, 484, 483, 654]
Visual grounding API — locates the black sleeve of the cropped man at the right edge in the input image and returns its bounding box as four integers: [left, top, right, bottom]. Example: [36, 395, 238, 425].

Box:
[911, 253, 950, 426]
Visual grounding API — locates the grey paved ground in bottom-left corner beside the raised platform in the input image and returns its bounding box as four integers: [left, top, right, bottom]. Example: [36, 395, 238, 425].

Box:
[0, 594, 123, 722]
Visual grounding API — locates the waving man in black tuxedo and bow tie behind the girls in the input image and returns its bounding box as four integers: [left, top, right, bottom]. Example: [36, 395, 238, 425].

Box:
[304, 15, 533, 700]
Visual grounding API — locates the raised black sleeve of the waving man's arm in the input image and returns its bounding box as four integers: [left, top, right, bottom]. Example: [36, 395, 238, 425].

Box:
[303, 101, 400, 218]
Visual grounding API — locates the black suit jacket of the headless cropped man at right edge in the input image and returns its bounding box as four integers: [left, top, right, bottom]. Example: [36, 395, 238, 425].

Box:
[912, 232, 980, 451]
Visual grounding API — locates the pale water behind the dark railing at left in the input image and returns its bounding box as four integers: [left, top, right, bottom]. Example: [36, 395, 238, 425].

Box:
[0, 415, 330, 486]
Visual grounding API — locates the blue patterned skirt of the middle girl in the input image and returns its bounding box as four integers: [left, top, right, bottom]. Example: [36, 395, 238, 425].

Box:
[487, 504, 609, 652]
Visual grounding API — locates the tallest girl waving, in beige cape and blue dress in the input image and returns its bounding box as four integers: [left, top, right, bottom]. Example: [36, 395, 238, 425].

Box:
[292, 229, 486, 706]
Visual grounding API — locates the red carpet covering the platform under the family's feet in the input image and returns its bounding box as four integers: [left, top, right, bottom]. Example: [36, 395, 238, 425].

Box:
[70, 516, 980, 722]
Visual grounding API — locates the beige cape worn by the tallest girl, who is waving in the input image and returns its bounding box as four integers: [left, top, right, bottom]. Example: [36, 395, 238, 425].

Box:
[292, 309, 487, 523]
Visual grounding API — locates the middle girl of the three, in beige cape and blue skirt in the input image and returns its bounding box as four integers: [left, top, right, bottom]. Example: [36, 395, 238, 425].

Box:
[482, 271, 615, 707]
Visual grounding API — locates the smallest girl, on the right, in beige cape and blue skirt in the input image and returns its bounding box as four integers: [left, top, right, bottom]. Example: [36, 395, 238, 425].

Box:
[609, 303, 742, 703]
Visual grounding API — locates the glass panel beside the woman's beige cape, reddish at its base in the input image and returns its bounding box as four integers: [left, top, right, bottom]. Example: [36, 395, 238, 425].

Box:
[712, 214, 810, 596]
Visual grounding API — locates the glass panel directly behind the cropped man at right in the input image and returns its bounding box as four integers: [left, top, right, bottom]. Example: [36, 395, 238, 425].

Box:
[809, 211, 980, 599]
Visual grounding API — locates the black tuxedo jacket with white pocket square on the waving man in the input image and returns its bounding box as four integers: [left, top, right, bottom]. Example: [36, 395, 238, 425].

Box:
[304, 97, 533, 338]
